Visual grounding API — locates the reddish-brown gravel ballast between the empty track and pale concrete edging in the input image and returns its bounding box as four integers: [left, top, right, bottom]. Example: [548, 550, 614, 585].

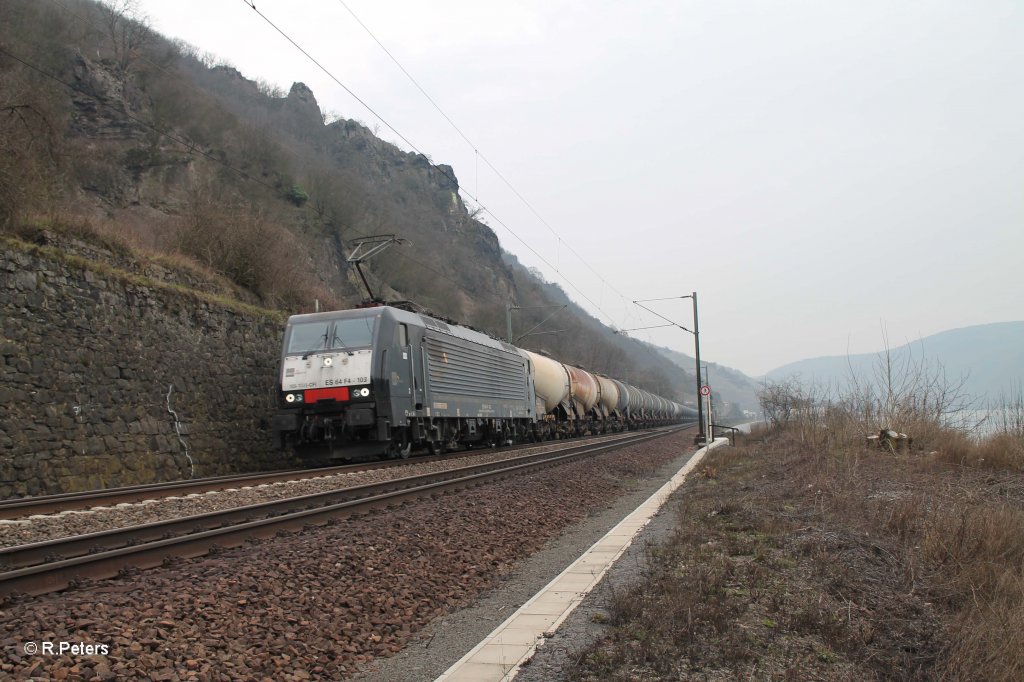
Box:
[0, 434, 692, 680]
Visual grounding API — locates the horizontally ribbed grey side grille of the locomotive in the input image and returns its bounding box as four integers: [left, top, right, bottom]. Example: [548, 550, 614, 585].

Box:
[425, 338, 526, 400]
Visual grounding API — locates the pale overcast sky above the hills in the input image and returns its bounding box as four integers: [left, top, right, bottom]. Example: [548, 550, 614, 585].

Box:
[141, 0, 1024, 375]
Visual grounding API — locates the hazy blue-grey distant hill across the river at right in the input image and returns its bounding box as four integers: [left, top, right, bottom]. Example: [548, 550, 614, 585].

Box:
[766, 322, 1024, 399]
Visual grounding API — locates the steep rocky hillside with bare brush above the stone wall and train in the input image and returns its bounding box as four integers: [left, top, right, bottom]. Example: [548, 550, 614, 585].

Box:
[0, 0, 692, 400]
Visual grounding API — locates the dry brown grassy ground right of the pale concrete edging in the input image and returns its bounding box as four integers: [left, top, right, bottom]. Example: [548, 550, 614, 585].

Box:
[571, 430, 1024, 681]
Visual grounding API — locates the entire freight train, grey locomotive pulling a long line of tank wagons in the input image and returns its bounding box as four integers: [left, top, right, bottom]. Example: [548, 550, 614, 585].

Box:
[271, 305, 696, 460]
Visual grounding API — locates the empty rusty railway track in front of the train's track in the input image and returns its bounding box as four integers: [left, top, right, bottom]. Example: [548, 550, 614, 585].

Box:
[0, 428, 677, 599]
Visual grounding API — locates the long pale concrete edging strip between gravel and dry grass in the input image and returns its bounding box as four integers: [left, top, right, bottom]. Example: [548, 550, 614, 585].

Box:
[436, 438, 728, 682]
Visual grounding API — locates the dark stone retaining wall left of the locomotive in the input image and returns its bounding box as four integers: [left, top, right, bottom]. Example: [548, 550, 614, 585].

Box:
[0, 240, 293, 499]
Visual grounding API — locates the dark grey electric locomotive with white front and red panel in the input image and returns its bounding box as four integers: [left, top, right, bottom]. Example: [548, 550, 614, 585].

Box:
[271, 306, 536, 460]
